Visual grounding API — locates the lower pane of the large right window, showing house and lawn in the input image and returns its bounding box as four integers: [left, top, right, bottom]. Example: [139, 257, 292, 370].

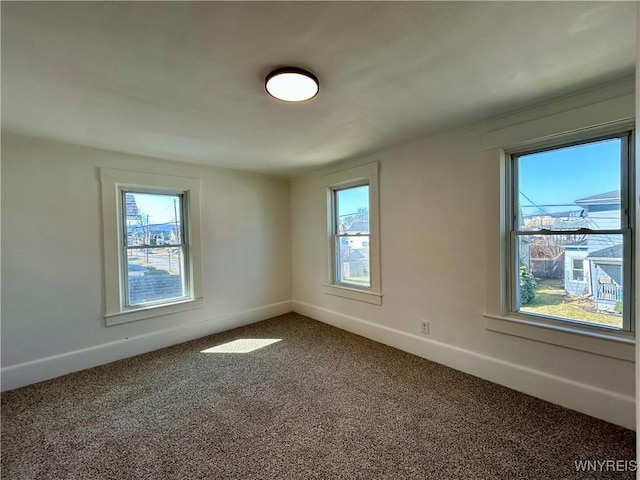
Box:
[516, 234, 624, 328]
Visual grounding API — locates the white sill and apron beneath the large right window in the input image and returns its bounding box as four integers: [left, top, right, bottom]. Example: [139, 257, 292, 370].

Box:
[484, 313, 635, 362]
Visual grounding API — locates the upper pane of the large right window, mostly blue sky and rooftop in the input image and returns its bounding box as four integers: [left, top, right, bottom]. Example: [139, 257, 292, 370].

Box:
[517, 138, 622, 230]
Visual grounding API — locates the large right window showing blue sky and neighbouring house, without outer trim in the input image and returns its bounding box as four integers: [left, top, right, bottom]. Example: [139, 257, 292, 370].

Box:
[507, 133, 633, 333]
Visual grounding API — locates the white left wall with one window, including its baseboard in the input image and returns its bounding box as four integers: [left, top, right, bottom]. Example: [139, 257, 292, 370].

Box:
[2, 134, 291, 389]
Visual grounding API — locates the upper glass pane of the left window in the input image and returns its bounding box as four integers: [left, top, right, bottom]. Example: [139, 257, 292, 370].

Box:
[124, 192, 182, 247]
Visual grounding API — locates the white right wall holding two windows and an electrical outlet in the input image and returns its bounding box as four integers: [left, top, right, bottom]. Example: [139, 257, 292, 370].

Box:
[291, 79, 635, 428]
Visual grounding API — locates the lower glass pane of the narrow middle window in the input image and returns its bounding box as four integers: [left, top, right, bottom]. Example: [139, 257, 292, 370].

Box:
[336, 235, 371, 287]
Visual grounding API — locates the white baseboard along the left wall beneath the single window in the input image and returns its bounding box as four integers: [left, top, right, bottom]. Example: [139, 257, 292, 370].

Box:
[0, 300, 292, 392]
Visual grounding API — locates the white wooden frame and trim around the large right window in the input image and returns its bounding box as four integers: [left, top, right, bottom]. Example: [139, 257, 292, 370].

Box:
[483, 121, 637, 362]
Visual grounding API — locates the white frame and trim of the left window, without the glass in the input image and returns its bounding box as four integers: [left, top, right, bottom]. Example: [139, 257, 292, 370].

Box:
[100, 168, 203, 326]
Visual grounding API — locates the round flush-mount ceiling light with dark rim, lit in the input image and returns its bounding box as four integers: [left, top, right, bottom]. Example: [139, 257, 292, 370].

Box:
[264, 67, 320, 102]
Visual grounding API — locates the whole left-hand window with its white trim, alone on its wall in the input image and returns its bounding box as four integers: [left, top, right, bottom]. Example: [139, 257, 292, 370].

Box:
[100, 168, 202, 325]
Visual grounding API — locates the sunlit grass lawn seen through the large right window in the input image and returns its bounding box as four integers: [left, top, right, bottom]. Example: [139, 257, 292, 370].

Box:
[520, 280, 622, 328]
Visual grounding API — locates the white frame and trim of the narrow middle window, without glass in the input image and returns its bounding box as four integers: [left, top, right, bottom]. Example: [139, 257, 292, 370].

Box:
[322, 162, 382, 305]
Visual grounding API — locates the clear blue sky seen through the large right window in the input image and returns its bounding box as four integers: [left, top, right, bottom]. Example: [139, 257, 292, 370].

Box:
[518, 139, 621, 215]
